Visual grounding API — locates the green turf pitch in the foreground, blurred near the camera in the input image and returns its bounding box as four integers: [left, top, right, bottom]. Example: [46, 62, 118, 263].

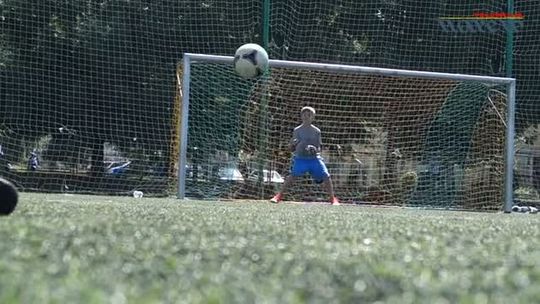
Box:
[0, 194, 540, 303]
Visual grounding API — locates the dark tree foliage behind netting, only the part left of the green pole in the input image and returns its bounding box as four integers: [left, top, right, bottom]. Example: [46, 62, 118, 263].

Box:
[0, 0, 260, 171]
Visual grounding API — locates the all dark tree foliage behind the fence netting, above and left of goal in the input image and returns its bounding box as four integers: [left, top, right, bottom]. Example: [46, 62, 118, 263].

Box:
[0, 0, 540, 195]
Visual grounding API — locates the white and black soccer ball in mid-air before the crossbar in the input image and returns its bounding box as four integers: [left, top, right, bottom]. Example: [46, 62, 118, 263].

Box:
[234, 43, 268, 78]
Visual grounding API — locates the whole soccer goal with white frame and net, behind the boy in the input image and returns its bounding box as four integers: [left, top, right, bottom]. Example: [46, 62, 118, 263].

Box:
[178, 54, 515, 210]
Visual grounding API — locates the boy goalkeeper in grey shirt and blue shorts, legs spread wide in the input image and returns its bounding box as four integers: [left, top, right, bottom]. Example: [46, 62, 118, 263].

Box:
[270, 107, 339, 205]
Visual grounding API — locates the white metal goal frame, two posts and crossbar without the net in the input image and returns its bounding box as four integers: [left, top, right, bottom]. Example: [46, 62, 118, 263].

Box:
[177, 53, 516, 212]
